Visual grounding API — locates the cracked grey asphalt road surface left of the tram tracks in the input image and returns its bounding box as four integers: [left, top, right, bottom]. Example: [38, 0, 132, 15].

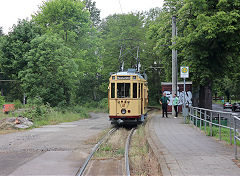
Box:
[0, 113, 110, 176]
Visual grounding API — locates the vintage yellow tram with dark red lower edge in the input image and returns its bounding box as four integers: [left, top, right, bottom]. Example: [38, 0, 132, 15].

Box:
[108, 69, 148, 124]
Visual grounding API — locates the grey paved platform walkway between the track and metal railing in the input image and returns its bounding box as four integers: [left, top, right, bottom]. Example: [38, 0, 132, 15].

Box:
[149, 113, 240, 176]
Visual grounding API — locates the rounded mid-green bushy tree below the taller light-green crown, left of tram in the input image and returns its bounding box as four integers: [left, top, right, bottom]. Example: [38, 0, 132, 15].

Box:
[19, 34, 77, 106]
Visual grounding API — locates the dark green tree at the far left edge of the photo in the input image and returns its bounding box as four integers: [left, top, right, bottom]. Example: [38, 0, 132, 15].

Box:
[0, 20, 41, 101]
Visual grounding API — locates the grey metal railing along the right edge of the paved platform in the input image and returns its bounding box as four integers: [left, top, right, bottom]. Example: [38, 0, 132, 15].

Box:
[189, 106, 240, 159]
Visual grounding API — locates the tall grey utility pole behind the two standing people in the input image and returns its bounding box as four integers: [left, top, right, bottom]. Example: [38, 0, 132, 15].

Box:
[172, 16, 177, 116]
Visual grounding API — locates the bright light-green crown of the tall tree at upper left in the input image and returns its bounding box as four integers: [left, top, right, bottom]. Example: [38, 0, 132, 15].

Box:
[33, 0, 90, 42]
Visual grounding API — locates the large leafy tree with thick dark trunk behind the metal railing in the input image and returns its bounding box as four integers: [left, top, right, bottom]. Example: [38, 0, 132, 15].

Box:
[178, 0, 240, 108]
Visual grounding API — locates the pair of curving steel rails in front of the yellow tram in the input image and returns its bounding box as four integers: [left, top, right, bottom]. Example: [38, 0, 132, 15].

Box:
[76, 128, 135, 176]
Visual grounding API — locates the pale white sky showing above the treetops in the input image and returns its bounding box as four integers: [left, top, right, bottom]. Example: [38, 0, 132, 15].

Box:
[0, 0, 163, 34]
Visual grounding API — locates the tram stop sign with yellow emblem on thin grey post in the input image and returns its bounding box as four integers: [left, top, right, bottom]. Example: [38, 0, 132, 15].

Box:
[180, 66, 189, 123]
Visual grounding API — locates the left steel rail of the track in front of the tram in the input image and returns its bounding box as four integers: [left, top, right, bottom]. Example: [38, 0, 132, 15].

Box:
[76, 128, 117, 176]
